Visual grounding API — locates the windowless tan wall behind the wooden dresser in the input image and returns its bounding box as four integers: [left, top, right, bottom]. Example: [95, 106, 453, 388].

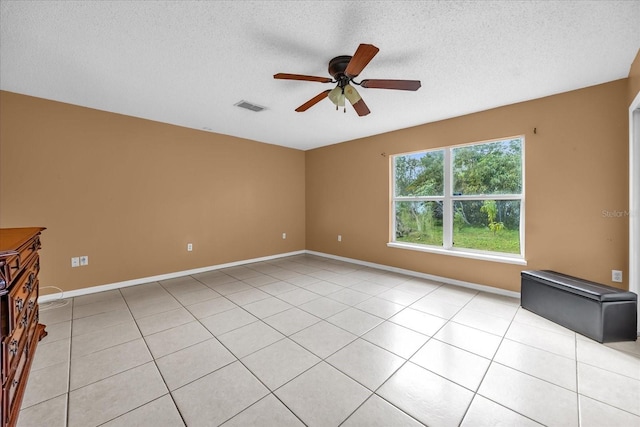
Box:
[0, 92, 305, 293]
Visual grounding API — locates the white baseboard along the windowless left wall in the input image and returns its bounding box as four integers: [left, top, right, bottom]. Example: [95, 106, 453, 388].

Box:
[38, 250, 306, 304]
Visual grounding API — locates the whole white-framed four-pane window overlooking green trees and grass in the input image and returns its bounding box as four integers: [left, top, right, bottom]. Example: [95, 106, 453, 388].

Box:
[390, 137, 524, 261]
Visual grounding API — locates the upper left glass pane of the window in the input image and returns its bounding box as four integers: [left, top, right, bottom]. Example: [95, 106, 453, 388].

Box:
[394, 150, 444, 197]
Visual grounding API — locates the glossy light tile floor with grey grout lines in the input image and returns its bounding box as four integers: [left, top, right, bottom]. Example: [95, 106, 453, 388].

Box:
[18, 255, 640, 427]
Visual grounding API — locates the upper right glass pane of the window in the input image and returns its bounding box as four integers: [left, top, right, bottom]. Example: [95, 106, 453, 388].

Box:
[452, 138, 522, 195]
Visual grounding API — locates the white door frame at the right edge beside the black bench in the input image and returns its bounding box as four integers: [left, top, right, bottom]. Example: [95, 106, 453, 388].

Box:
[629, 93, 640, 336]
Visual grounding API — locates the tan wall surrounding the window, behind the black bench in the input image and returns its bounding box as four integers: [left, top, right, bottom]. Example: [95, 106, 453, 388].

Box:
[306, 79, 629, 291]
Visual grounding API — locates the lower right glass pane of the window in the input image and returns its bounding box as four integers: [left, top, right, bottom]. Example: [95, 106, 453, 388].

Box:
[453, 200, 520, 254]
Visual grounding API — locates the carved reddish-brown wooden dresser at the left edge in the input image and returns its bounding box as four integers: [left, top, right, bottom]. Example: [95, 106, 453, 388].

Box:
[0, 227, 47, 427]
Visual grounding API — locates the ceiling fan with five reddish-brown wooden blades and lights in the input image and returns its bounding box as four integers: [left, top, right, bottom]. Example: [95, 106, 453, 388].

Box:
[273, 44, 420, 116]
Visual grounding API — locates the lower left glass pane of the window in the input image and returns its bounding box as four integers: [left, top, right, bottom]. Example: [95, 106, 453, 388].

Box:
[395, 202, 442, 246]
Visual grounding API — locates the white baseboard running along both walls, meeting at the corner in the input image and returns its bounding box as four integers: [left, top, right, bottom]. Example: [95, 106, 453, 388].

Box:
[38, 250, 520, 304]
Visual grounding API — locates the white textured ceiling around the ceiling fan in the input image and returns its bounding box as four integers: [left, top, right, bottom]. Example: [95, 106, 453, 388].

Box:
[0, 0, 640, 150]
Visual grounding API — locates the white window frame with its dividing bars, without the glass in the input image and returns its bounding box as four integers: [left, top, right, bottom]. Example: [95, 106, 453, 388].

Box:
[387, 135, 527, 265]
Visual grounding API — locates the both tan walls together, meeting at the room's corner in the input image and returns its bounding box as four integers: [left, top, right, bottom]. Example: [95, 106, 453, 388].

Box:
[0, 75, 640, 293]
